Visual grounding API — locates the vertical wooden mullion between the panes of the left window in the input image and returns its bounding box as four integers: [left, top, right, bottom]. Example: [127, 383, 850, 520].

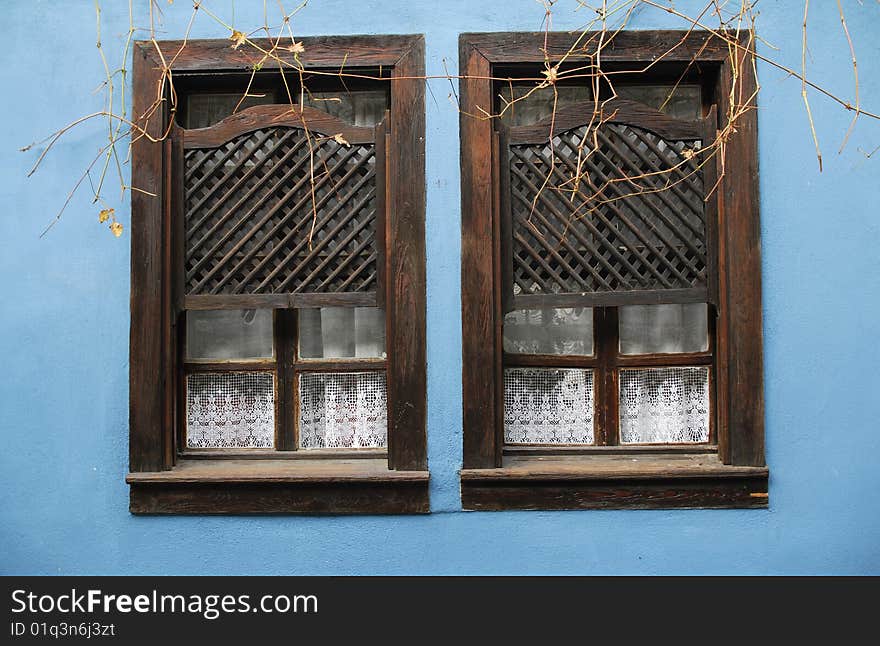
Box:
[275, 309, 299, 451]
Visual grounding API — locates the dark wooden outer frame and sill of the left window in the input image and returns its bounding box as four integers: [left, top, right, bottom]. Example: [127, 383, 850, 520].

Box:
[126, 35, 429, 514]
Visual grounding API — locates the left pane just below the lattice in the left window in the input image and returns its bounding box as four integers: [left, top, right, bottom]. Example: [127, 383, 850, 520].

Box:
[186, 310, 273, 361]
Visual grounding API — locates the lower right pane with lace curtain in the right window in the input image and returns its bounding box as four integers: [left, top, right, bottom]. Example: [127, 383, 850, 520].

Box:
[620, 368, 709, 444]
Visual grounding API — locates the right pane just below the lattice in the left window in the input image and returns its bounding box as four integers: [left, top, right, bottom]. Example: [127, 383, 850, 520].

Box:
[299, 307, 385, 359]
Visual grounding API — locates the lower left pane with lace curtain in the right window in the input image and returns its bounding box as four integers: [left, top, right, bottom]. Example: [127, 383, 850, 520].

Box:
[504, 368, 593, 444]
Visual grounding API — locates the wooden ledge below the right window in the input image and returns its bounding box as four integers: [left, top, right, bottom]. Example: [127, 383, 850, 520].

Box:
[461, 454, 769, 511]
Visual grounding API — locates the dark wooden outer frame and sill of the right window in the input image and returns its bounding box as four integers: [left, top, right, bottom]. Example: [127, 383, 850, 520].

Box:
[459, 31, 769, 510]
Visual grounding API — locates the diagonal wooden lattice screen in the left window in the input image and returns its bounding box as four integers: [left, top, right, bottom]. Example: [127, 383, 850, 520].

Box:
[184, 127, 378, 295]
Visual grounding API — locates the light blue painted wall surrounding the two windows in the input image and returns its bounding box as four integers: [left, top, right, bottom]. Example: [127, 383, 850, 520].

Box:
[0, 0, 880, 574]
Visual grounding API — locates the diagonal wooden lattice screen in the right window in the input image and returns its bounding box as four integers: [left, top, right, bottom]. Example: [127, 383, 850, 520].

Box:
[509, 123, 707, 294]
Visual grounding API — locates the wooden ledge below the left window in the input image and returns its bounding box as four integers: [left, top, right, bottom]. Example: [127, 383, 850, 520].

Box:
[125, 459, 429, 514]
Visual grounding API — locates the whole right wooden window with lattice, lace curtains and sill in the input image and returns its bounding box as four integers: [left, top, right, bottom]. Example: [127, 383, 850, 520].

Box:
[460, 32, 768, 509]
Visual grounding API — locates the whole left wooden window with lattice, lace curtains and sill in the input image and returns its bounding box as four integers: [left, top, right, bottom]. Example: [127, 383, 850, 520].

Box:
[127, 36, 428, 513]
